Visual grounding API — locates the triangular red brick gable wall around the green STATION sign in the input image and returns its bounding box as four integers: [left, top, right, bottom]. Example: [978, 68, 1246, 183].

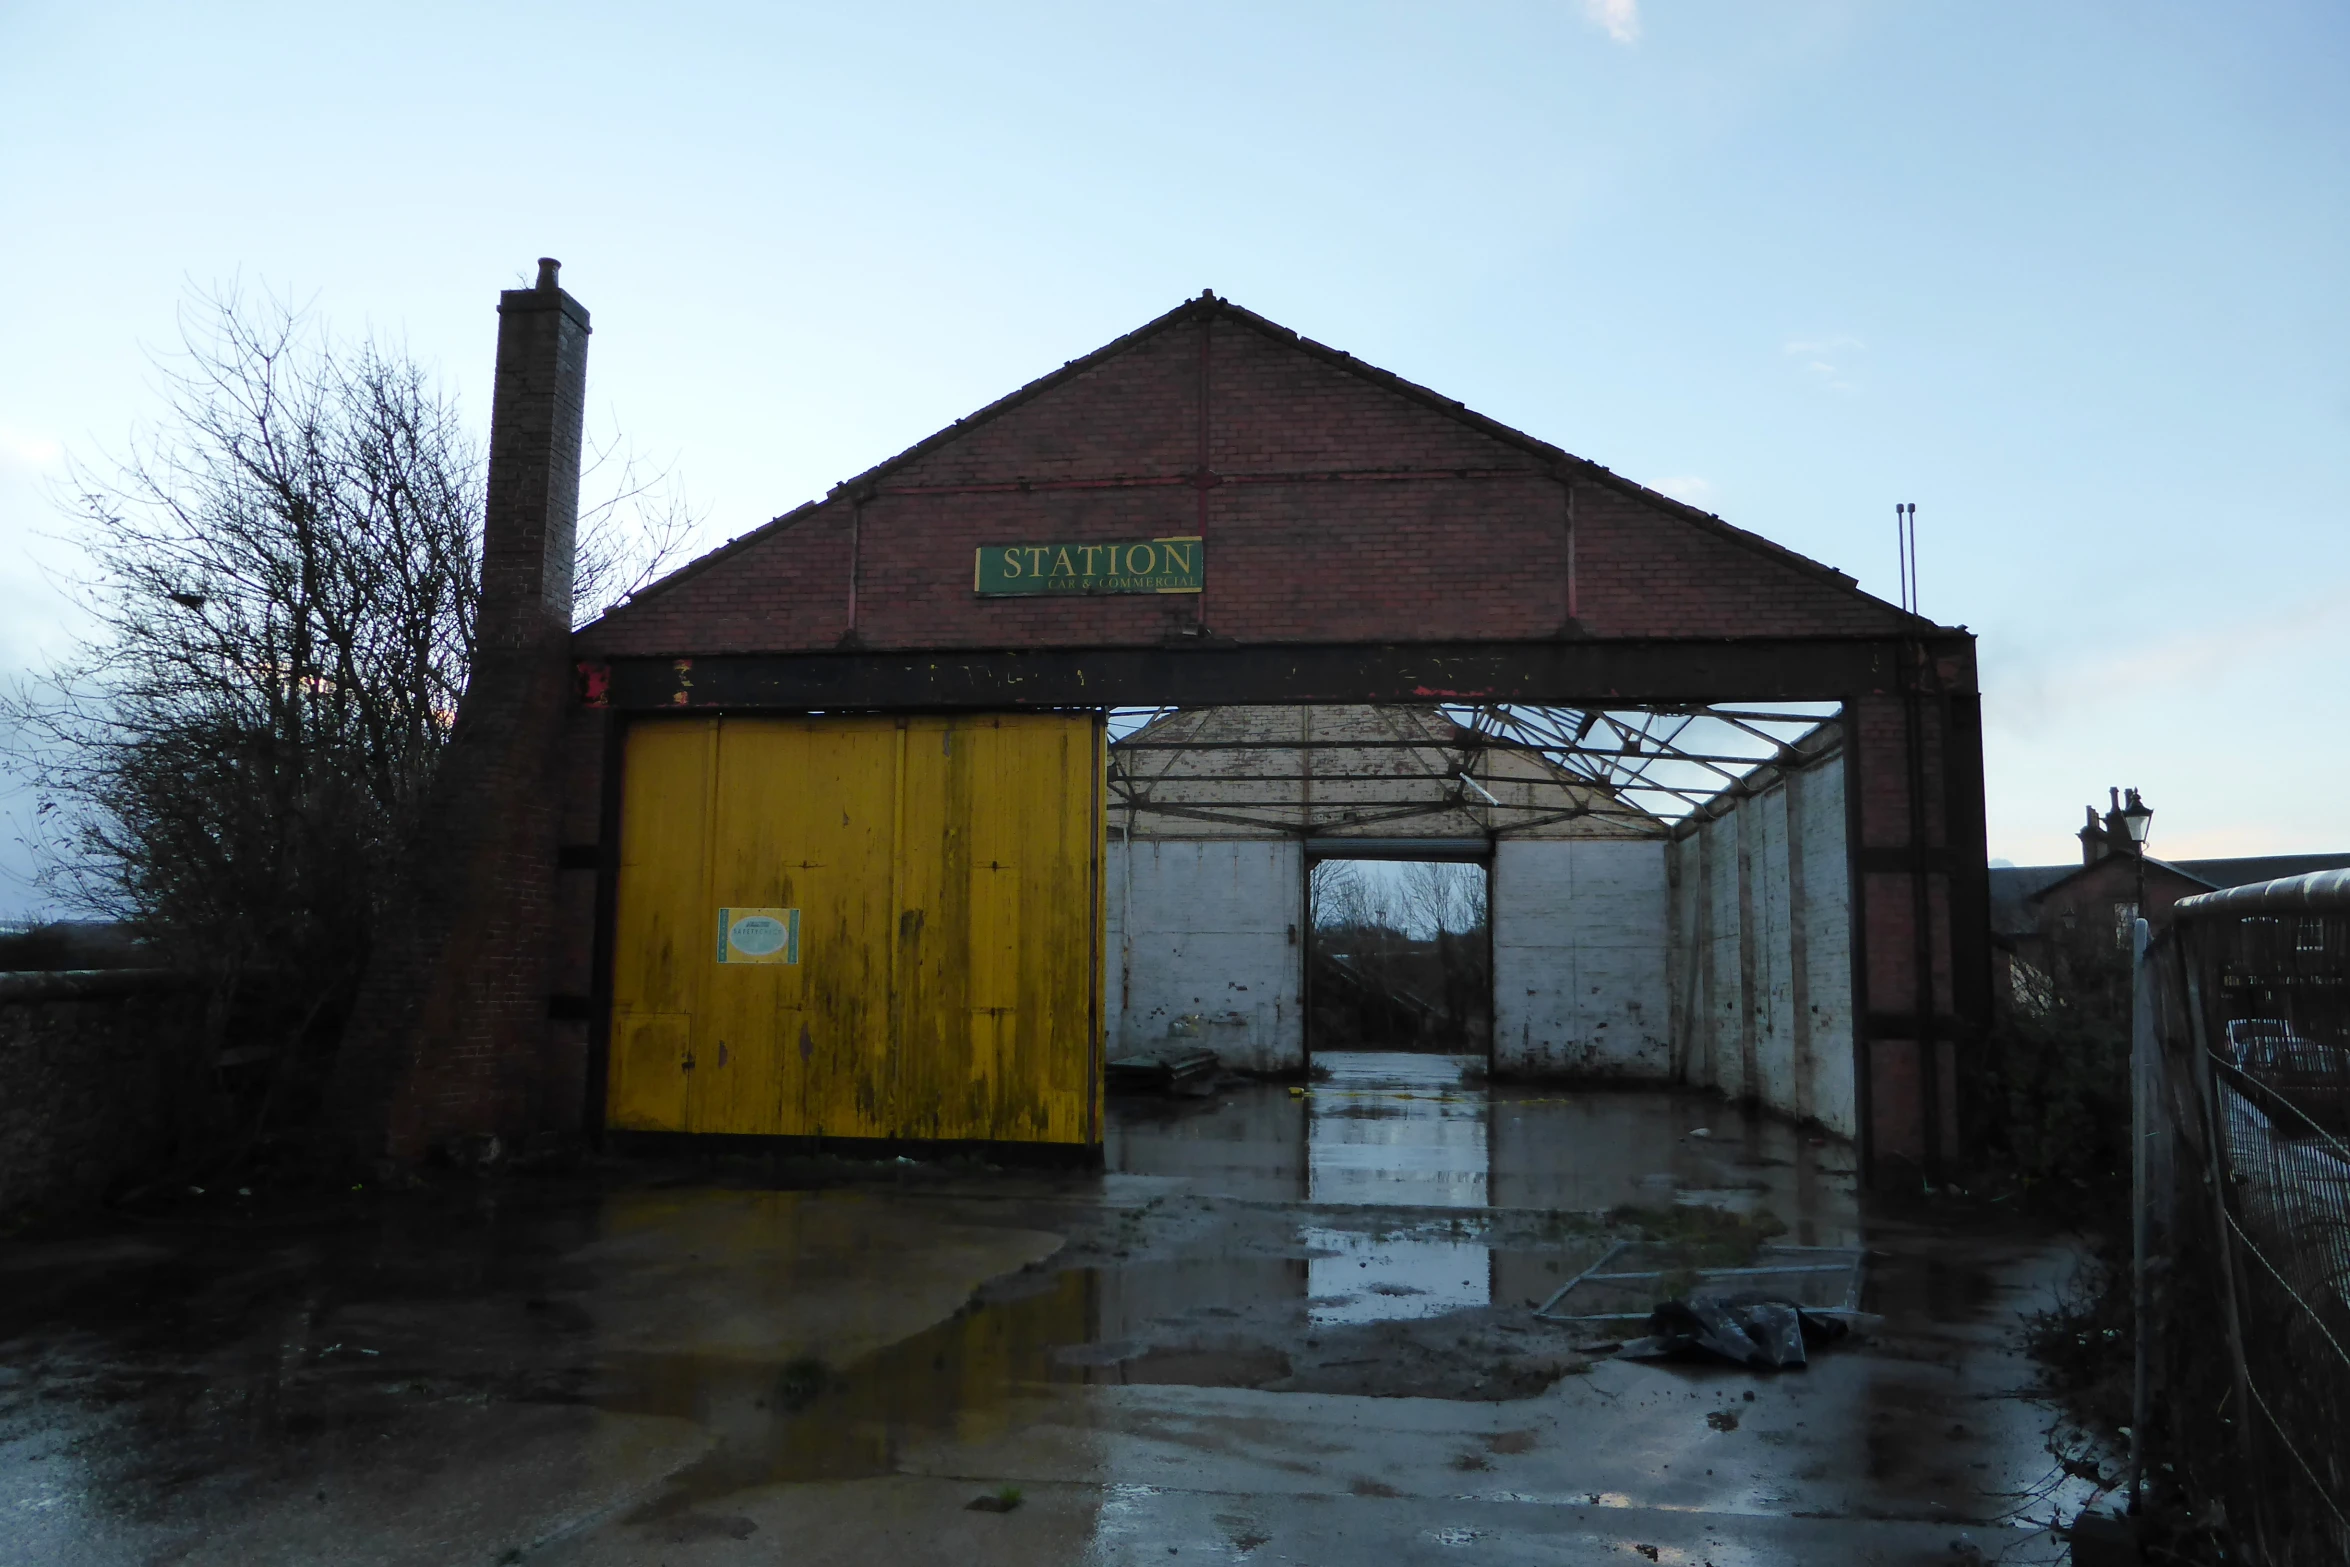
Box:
[578, 301, 1904, 658]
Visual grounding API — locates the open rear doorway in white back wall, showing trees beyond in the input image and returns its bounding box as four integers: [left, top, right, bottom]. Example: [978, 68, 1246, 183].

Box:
[1307, 858, 1492, 1060]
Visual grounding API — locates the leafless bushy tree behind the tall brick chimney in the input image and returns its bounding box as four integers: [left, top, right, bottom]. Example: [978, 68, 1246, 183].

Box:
[0, 291, 691, 1141]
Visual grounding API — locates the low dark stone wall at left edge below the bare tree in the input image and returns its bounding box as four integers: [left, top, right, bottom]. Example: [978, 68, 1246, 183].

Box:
[0, 968, 202, 1229]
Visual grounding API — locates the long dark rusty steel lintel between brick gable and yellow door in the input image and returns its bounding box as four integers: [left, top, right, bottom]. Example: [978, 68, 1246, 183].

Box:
[583, 637, 1972, 712]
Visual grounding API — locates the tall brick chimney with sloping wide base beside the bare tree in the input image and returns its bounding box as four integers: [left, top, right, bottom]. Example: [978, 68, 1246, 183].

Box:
[327, 258, 588, 1163]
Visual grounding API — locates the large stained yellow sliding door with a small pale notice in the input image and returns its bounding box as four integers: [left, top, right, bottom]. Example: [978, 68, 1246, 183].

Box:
[606, 714, 1102, 1144]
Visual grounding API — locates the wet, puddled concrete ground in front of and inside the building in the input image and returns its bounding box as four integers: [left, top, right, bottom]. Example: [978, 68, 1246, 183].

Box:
[0, 1057, 2089, 1567]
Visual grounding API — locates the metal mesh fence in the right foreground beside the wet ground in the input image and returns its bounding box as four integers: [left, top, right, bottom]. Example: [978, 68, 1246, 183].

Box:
[2131, 872, 2350, 1567]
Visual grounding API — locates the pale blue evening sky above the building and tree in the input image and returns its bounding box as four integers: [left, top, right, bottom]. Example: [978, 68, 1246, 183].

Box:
[0, 0, 2350, 916]
